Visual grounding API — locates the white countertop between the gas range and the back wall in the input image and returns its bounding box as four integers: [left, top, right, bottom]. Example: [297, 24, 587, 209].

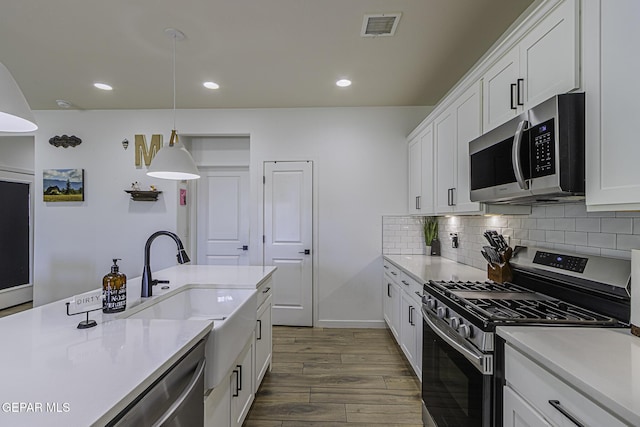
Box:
[384, 255, 487, 283]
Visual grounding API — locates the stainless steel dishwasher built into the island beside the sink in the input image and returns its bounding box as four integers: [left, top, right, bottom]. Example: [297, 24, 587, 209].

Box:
[107, 340, 205, 427]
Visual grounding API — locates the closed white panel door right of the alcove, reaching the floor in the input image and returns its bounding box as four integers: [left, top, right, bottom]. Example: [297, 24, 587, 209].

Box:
[264, 162, 313, 326]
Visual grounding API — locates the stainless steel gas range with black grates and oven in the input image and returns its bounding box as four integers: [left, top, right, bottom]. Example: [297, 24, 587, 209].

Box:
[422, 247, 631, 427]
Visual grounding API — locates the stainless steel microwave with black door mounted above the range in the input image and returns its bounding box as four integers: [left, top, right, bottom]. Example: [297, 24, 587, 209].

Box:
[469, 93, 585, 204]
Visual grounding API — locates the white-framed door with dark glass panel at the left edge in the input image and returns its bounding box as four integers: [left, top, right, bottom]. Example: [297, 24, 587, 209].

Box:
[0, 171, 35, 309]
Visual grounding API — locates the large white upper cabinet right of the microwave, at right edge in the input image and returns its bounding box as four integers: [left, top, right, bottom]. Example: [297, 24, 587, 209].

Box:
[583, 0, 640, 211]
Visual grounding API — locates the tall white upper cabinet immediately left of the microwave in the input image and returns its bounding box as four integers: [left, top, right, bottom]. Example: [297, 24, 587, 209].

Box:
[433, 82, 482, 214]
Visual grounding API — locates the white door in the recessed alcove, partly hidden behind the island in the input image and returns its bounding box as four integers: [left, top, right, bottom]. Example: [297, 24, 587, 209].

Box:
[196, 168, 249, 265]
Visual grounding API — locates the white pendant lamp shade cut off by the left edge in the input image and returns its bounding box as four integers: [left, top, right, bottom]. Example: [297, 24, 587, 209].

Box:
[0, 63, 38, 132]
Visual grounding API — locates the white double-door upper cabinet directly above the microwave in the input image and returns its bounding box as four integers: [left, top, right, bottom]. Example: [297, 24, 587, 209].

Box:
[482, 0, 580, 132]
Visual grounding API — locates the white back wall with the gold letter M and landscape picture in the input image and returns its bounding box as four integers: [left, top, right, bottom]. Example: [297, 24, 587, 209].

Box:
[34, 107, 428, 326]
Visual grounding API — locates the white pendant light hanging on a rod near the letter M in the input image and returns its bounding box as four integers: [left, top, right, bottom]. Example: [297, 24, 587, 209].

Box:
[147, 28, 200, 181]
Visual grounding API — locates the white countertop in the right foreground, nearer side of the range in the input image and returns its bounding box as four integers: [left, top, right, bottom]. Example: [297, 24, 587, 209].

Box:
[497, 326, 640, 426]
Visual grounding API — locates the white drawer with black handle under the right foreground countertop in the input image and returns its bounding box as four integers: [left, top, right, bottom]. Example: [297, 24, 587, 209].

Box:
[505, 345, 626, 427]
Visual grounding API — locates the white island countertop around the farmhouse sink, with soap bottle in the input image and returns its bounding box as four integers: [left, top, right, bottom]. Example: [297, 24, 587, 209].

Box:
[0, 265, 275, 427]
